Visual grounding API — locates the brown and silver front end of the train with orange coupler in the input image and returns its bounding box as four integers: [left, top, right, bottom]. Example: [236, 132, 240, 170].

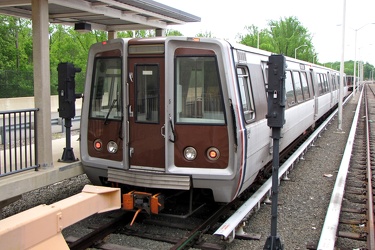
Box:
[81, 38, 243, 212]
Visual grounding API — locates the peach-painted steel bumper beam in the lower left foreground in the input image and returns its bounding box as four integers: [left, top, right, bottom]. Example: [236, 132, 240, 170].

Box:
[0, 185, 121, 250]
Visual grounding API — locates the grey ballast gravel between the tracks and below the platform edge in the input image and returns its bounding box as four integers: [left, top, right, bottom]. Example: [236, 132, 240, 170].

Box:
[2, 94, 359, 250]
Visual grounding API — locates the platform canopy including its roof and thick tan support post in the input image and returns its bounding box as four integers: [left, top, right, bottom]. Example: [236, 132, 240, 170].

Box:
[0, 0, 201, 169]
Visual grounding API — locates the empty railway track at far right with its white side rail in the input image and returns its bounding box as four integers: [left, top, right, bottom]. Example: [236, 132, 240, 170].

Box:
[318, 84, 375, 249]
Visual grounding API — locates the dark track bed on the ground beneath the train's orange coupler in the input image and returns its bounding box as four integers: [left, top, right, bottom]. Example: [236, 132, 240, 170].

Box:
[66, 203, 233, 250]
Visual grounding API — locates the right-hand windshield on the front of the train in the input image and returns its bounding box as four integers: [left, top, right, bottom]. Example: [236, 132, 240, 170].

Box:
[176, 56, 225, 124]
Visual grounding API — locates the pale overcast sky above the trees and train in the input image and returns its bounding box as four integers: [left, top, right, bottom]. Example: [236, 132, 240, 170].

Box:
[155, 0, 375, 66]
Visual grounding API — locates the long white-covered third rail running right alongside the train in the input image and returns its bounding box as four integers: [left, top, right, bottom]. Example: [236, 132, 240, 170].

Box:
[214, 95, 352, 241]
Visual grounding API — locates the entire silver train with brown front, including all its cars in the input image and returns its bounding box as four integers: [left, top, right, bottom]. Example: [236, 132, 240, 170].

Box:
[80, 37, 348, 216]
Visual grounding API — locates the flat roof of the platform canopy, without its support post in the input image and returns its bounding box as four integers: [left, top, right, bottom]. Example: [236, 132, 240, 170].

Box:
[0, 0, 201, 31]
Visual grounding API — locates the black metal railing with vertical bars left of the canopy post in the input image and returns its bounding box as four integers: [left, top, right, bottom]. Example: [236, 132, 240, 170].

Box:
[0, 108, 38, 177]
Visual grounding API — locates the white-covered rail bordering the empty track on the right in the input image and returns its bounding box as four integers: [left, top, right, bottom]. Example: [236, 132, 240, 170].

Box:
[317, 90, 363, 250]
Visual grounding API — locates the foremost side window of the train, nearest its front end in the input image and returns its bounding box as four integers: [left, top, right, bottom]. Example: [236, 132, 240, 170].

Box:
[237, 67, 255, 123]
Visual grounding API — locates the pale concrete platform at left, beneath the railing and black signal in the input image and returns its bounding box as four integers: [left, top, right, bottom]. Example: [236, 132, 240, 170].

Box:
[0, 135, 83, 209]
